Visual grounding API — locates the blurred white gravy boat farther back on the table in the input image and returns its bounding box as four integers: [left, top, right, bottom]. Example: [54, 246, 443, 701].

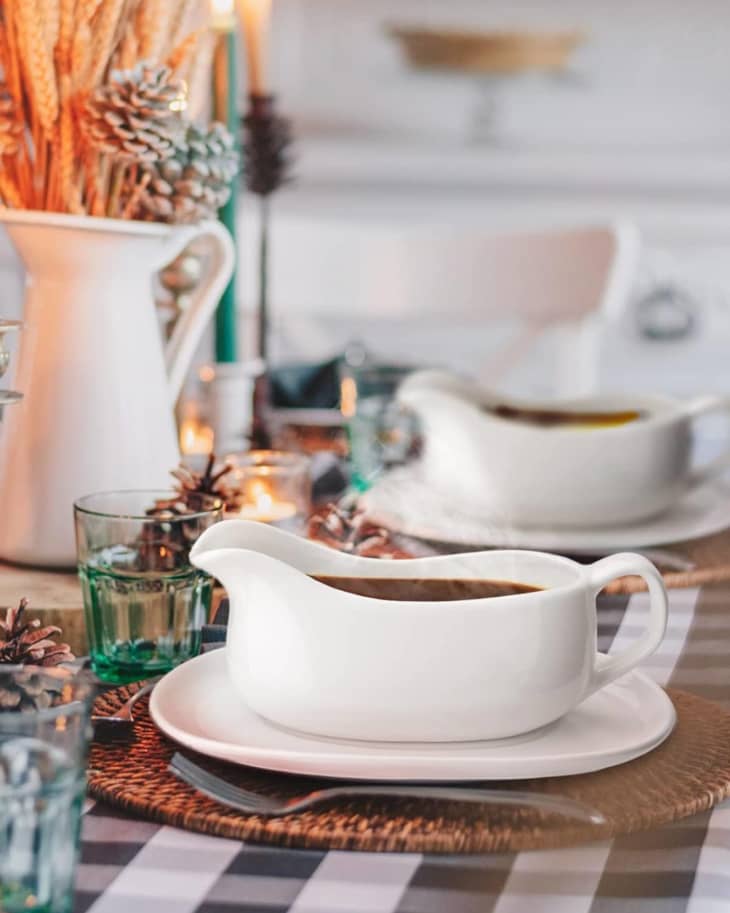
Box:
[398, 371, 730, 528]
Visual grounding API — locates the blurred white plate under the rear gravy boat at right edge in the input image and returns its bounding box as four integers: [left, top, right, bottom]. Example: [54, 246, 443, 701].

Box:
[360, 467, 730, 553]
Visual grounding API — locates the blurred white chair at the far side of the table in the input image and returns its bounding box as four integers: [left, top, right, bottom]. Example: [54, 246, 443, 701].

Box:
[245, 219, 640, 393]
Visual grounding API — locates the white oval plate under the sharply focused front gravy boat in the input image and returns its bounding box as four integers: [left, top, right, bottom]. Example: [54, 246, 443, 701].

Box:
[150, 649, 676, 781]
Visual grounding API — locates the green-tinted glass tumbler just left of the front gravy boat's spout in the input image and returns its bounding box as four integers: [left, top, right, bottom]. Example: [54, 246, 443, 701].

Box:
[74, 491, 223, 683]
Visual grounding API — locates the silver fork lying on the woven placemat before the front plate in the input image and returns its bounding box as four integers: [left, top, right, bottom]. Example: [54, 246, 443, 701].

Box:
[168, 752, 606, 825]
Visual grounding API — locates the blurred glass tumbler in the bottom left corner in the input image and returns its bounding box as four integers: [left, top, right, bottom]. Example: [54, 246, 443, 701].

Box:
[0, 665, 94, 913]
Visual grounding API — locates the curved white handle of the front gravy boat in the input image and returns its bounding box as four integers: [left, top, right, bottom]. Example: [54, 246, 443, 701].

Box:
[584, 552, 668, 697]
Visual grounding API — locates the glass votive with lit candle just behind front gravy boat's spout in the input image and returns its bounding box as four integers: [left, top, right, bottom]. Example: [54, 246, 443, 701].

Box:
[225, 450, 312, 533]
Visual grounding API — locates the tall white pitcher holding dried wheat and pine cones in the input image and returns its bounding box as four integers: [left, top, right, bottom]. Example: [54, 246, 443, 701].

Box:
[0, 211, 235, 567]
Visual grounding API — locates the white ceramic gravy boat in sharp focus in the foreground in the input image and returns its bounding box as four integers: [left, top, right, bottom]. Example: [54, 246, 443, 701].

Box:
[191, 520, 667, 742]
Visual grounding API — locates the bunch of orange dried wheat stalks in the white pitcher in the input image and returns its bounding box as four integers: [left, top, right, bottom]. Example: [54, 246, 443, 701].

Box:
[0, 0, 208, 217]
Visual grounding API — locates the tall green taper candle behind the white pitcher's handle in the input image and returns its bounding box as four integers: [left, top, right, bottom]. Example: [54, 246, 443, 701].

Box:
[213, 31, 238, 362]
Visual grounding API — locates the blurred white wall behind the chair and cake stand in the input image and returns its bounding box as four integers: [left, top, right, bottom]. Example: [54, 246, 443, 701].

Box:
[5, 0, 730, 400]
